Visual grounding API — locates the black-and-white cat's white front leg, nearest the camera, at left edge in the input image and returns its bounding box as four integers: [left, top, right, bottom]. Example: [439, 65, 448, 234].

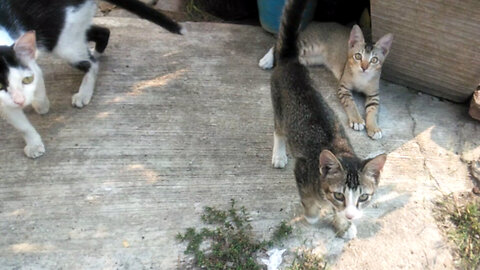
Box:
[2, 107, 45, 158]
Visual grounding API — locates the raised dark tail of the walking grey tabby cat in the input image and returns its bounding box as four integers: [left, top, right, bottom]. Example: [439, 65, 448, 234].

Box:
[275, 0, 307, 62]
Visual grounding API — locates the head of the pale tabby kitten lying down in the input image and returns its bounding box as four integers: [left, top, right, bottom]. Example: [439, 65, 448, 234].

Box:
[348, 25, 393, 74]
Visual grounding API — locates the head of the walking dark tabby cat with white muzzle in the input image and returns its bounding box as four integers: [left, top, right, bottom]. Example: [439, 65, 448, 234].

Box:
[319, 150, 387, 220]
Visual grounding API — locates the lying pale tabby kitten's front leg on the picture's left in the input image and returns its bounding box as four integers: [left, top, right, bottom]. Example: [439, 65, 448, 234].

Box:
[337, 81, 365, 131]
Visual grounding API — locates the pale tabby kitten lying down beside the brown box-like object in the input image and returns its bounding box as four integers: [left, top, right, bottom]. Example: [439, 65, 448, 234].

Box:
[259, 22, 393, 140]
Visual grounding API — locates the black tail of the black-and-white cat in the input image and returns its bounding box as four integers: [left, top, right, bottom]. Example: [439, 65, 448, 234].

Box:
[106, 0, 185, 34]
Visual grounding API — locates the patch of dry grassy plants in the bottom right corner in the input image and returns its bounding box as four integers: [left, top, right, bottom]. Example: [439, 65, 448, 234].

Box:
[437, 195, 480, 269]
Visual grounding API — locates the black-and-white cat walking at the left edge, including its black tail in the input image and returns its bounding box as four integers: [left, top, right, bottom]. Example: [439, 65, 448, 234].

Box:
[0, 0, 184, 158]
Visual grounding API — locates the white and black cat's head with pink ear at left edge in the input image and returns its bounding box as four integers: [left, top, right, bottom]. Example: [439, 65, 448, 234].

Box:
[0, 31, 41, 108]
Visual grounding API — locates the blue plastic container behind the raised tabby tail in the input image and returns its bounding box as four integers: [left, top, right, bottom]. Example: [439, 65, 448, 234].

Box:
[257, 0, 317, 34]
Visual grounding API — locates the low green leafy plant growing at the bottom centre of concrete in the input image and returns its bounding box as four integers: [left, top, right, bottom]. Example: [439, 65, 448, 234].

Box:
[177, 200, 280, 270]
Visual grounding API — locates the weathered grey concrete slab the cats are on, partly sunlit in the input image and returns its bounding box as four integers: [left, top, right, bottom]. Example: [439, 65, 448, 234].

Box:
[0, 18, 480, 269]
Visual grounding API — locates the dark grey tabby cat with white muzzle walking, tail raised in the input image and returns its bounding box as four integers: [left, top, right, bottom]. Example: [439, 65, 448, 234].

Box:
[271, 0, 387, 239]
